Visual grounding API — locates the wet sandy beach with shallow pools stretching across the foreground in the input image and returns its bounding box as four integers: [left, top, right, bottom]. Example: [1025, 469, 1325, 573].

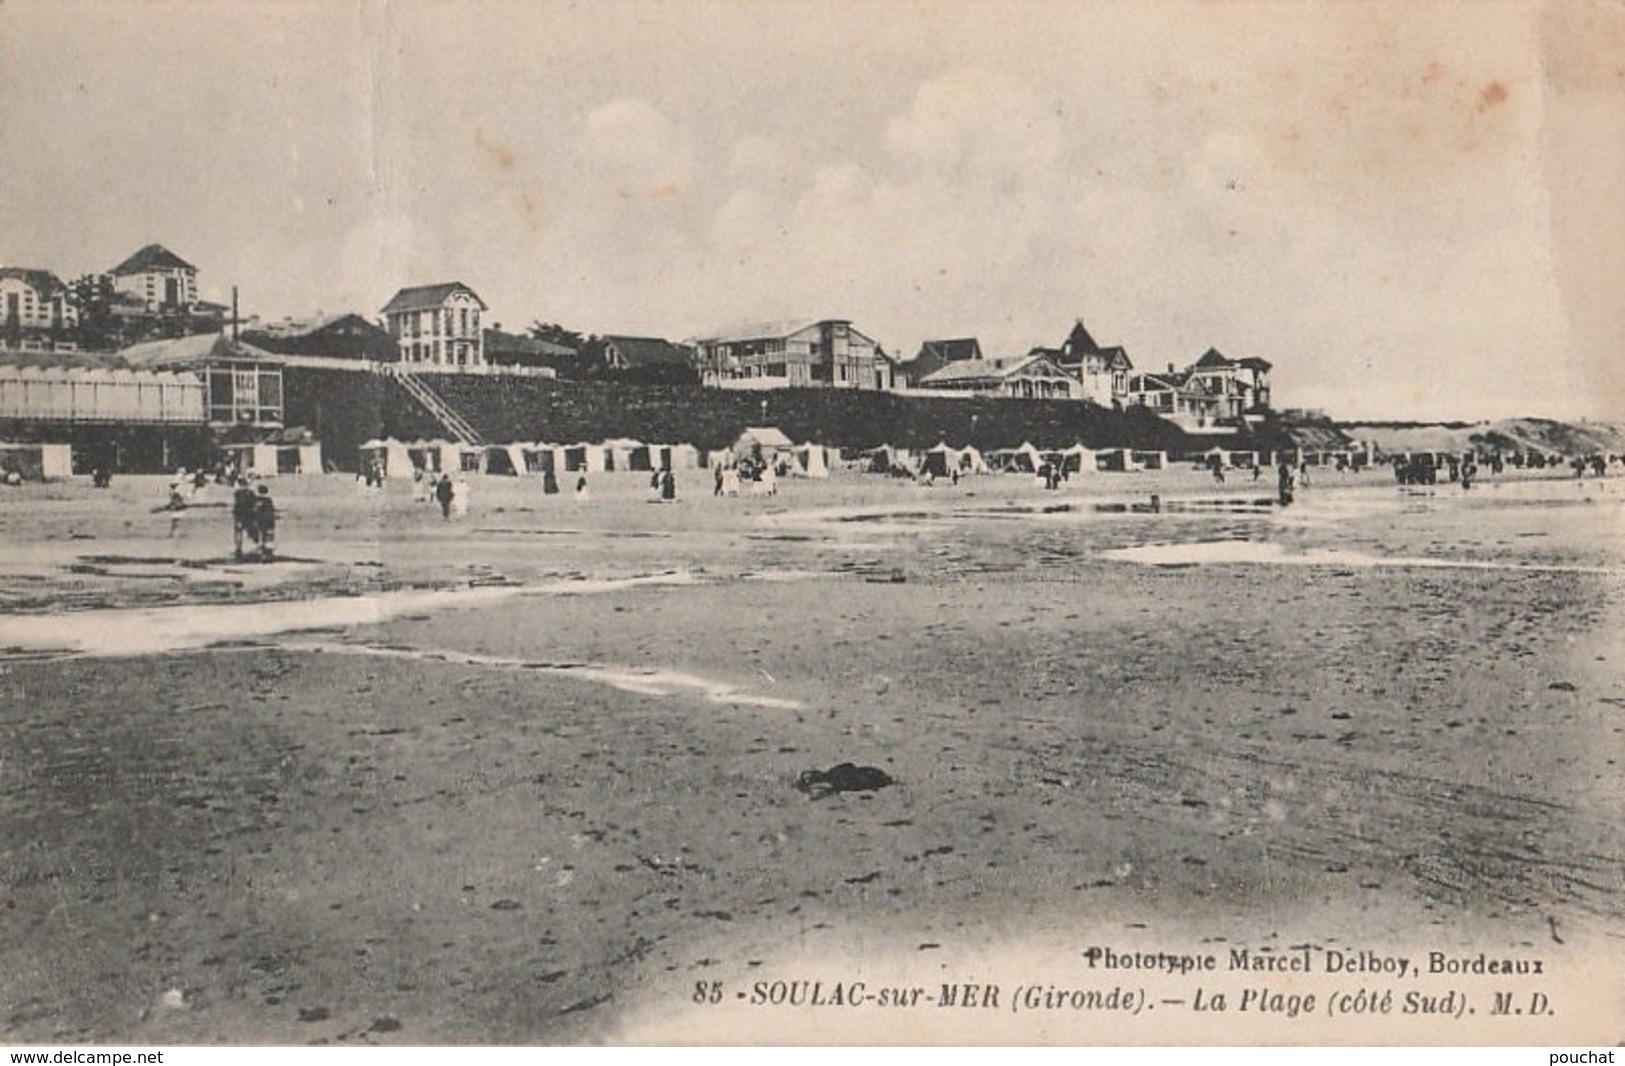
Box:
[0, 471, 1625, 1043]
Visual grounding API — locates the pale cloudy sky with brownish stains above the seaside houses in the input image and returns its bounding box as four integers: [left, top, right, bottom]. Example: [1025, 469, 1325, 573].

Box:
[0, 0, 1625, 418]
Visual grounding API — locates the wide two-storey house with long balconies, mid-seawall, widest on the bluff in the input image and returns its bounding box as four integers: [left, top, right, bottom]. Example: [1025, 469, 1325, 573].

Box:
[694, 319, 895, 390]
